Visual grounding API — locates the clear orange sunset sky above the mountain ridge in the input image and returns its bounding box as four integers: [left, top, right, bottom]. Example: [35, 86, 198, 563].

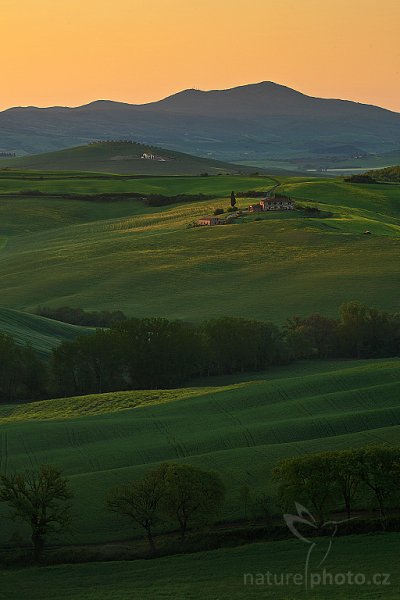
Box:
[0, 0, 400, 111]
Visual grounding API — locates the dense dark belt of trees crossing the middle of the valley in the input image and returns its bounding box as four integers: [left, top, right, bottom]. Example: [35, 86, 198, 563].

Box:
[0, 302, 400, 401]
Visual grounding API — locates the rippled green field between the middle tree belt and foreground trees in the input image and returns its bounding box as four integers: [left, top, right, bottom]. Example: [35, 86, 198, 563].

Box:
[0, 360, 400, 544]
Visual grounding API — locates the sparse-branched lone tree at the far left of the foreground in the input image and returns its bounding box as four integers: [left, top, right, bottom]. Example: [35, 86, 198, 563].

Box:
[0, 465, 72, 563]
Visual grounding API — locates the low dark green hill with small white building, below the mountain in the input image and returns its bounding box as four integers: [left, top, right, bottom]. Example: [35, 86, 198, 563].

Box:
[0, 142, 251, 175]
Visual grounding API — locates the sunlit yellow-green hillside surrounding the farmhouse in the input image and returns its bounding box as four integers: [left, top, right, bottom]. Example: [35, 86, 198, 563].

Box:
[0, 174, 400, 322]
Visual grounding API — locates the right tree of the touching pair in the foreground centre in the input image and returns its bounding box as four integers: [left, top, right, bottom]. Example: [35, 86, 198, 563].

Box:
[162, 463, 225, 541]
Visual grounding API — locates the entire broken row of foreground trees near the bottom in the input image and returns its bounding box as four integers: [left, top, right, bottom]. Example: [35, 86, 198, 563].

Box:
[0, 445, 400, 562]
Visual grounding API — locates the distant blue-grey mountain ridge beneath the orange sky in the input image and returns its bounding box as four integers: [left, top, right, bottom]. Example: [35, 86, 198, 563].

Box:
[0, 82, 400, 165]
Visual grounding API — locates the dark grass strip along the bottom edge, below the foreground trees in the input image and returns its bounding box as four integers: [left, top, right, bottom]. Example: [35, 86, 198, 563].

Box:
[2, 533, 400, 600]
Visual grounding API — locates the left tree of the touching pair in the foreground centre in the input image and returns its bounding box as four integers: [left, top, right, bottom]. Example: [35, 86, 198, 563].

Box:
[106, 465, 167, 554]
